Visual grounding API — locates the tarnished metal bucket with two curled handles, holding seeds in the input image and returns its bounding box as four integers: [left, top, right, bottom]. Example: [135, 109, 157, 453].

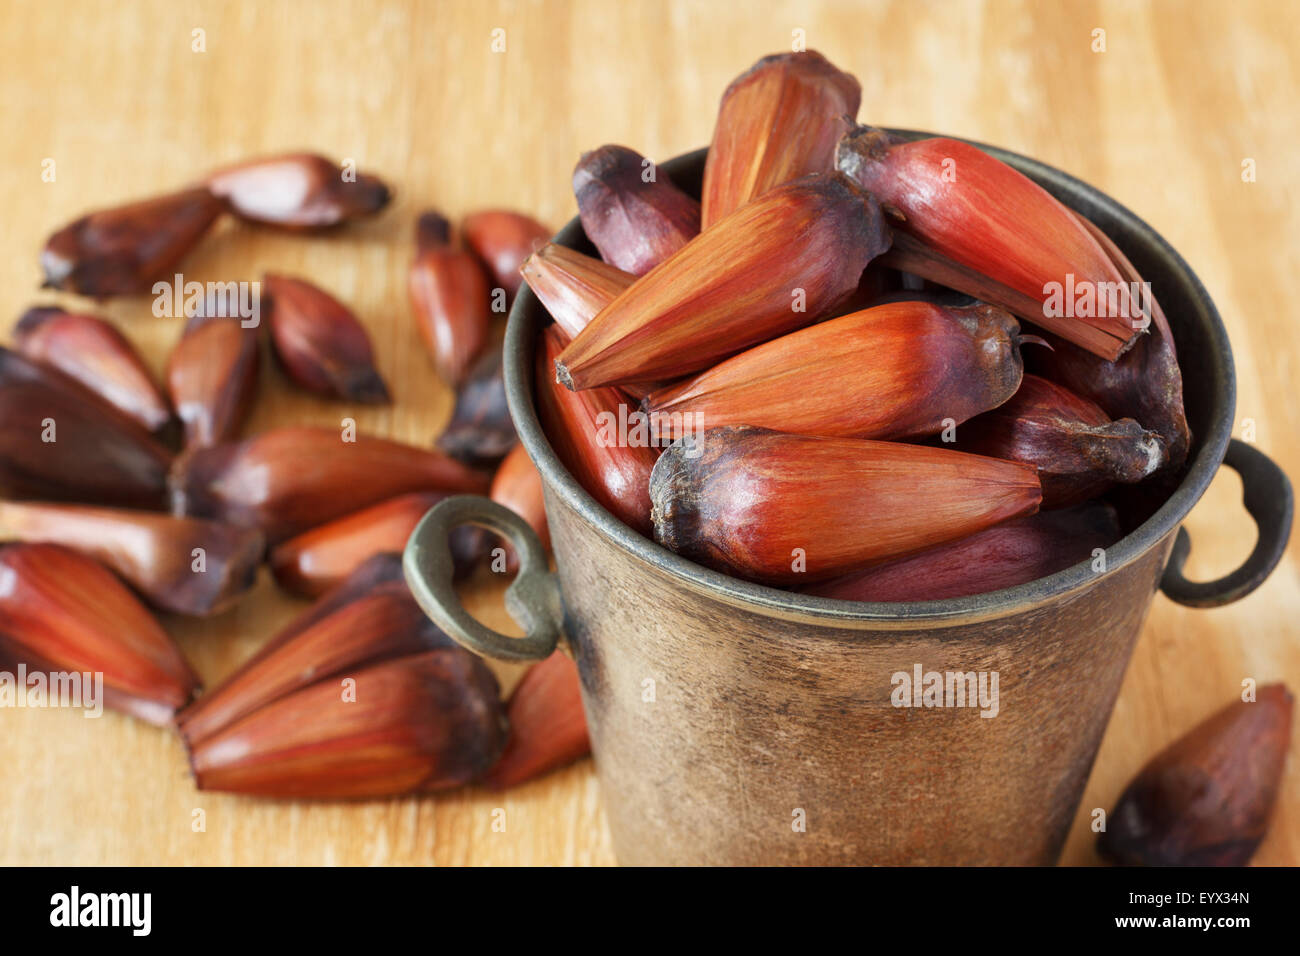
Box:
[406, 131, 1292, 864]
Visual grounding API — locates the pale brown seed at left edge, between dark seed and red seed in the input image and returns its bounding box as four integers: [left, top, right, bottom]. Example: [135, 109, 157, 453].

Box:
[0, 501, 265, 616]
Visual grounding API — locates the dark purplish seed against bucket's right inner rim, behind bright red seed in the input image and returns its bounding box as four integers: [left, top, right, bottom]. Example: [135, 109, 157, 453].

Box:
[1031, 216, 1191, 471]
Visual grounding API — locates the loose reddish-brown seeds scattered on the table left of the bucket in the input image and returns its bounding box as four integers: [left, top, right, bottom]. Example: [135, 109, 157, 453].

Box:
[0, 155, 579, 797]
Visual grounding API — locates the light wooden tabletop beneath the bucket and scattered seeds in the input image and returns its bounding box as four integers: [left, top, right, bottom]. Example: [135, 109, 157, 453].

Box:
[0, 0, 1300, 864]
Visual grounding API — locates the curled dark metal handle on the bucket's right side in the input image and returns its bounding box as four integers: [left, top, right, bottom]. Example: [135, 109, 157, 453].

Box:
[1160, 438, 1295, 607]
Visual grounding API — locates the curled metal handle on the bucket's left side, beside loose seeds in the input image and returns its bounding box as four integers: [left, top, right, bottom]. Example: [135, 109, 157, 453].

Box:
[402, 494, 563, 661]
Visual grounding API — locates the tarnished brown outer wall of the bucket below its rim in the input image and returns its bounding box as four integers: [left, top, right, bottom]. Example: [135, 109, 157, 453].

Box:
[547, 486, 1169, 864]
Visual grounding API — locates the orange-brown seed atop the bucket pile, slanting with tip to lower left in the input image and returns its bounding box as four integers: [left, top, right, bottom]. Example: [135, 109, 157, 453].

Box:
[555, 173, 889, 389]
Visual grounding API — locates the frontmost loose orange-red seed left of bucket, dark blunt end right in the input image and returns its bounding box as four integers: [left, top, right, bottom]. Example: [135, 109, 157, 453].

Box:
[190, 648, 506, 799]
